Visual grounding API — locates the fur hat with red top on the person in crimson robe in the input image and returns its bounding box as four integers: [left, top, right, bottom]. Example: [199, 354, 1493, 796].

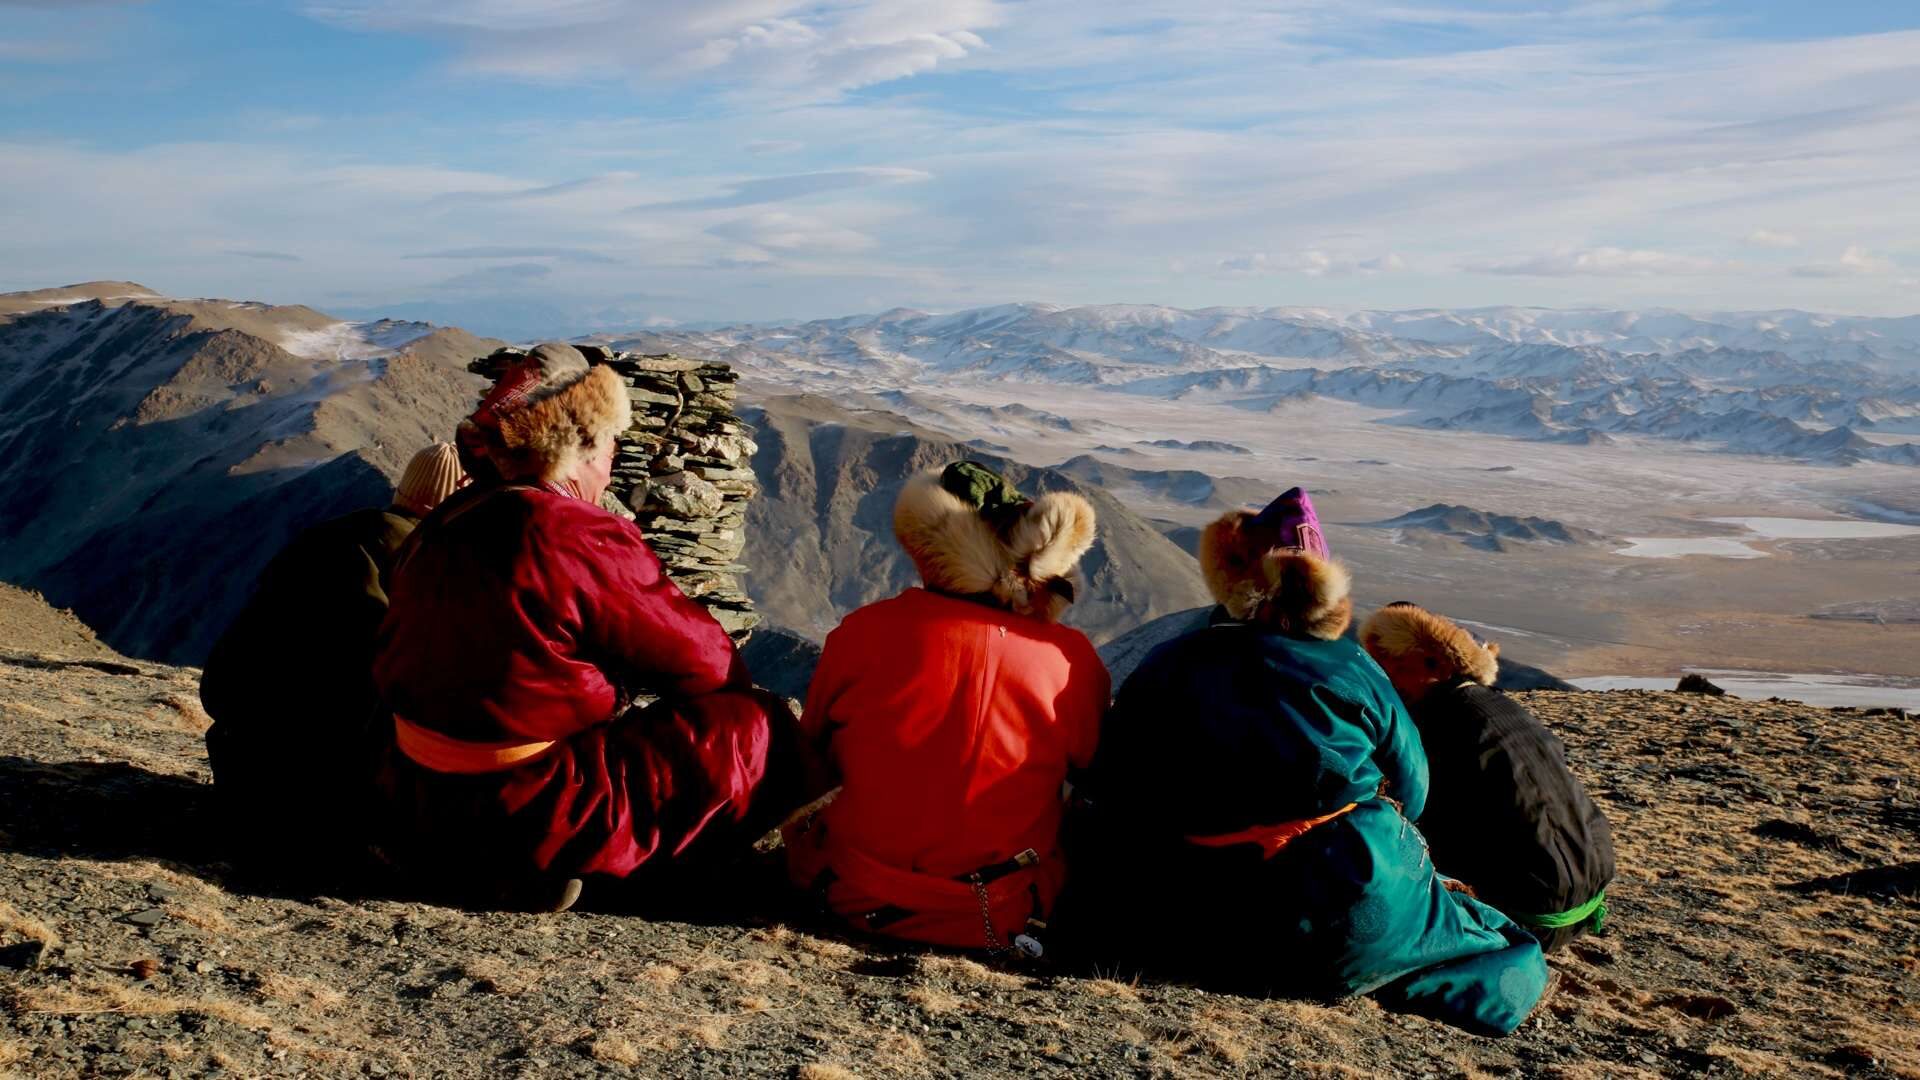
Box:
[486, 367, 634, 480]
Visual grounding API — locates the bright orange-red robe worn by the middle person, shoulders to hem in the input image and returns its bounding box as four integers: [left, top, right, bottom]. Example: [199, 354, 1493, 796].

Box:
[789, 588, 1108, 947]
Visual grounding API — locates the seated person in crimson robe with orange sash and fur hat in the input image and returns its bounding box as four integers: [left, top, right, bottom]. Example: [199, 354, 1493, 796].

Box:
[374, 367, 803, 909]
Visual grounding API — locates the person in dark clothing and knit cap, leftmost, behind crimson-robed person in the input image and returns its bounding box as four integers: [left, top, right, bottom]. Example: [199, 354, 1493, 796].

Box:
[200, 442, 465, 872]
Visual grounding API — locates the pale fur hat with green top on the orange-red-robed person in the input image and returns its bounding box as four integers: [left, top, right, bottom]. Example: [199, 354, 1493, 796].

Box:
[893, 461, 1094, 621]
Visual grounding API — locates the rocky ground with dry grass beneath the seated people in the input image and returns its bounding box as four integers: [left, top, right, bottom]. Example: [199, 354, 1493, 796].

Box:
[0, 598, 1920, 1080]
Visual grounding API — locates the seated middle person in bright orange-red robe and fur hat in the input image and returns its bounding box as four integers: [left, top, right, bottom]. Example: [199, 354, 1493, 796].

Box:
[787, 461, 1110, 953]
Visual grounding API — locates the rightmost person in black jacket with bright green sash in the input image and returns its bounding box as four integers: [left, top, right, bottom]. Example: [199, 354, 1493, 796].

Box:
[1359, 603, 1613, 951]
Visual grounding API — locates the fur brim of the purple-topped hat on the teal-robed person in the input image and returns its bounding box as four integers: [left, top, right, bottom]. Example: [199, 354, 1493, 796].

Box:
[1200, 509, 1354, 642]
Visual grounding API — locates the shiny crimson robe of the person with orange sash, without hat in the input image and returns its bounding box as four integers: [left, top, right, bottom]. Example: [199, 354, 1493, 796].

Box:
[374, 486, 793, 876]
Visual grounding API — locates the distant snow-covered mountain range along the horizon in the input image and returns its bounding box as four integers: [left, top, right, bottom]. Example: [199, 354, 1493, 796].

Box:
[618, 304, 1920, 465]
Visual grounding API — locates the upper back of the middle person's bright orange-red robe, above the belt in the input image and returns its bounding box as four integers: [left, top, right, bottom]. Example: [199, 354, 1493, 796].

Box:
[810, 588, 1106, 876]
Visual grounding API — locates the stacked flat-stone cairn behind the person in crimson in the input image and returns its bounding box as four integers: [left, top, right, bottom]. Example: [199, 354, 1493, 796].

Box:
[468, 346, 760, 644]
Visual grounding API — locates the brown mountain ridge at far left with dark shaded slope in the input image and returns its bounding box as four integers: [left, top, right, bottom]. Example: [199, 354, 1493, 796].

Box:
[0, 282, 490, 663]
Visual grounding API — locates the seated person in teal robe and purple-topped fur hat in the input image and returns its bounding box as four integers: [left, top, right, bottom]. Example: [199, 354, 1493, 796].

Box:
[1071, 492, 1548, 1034]
